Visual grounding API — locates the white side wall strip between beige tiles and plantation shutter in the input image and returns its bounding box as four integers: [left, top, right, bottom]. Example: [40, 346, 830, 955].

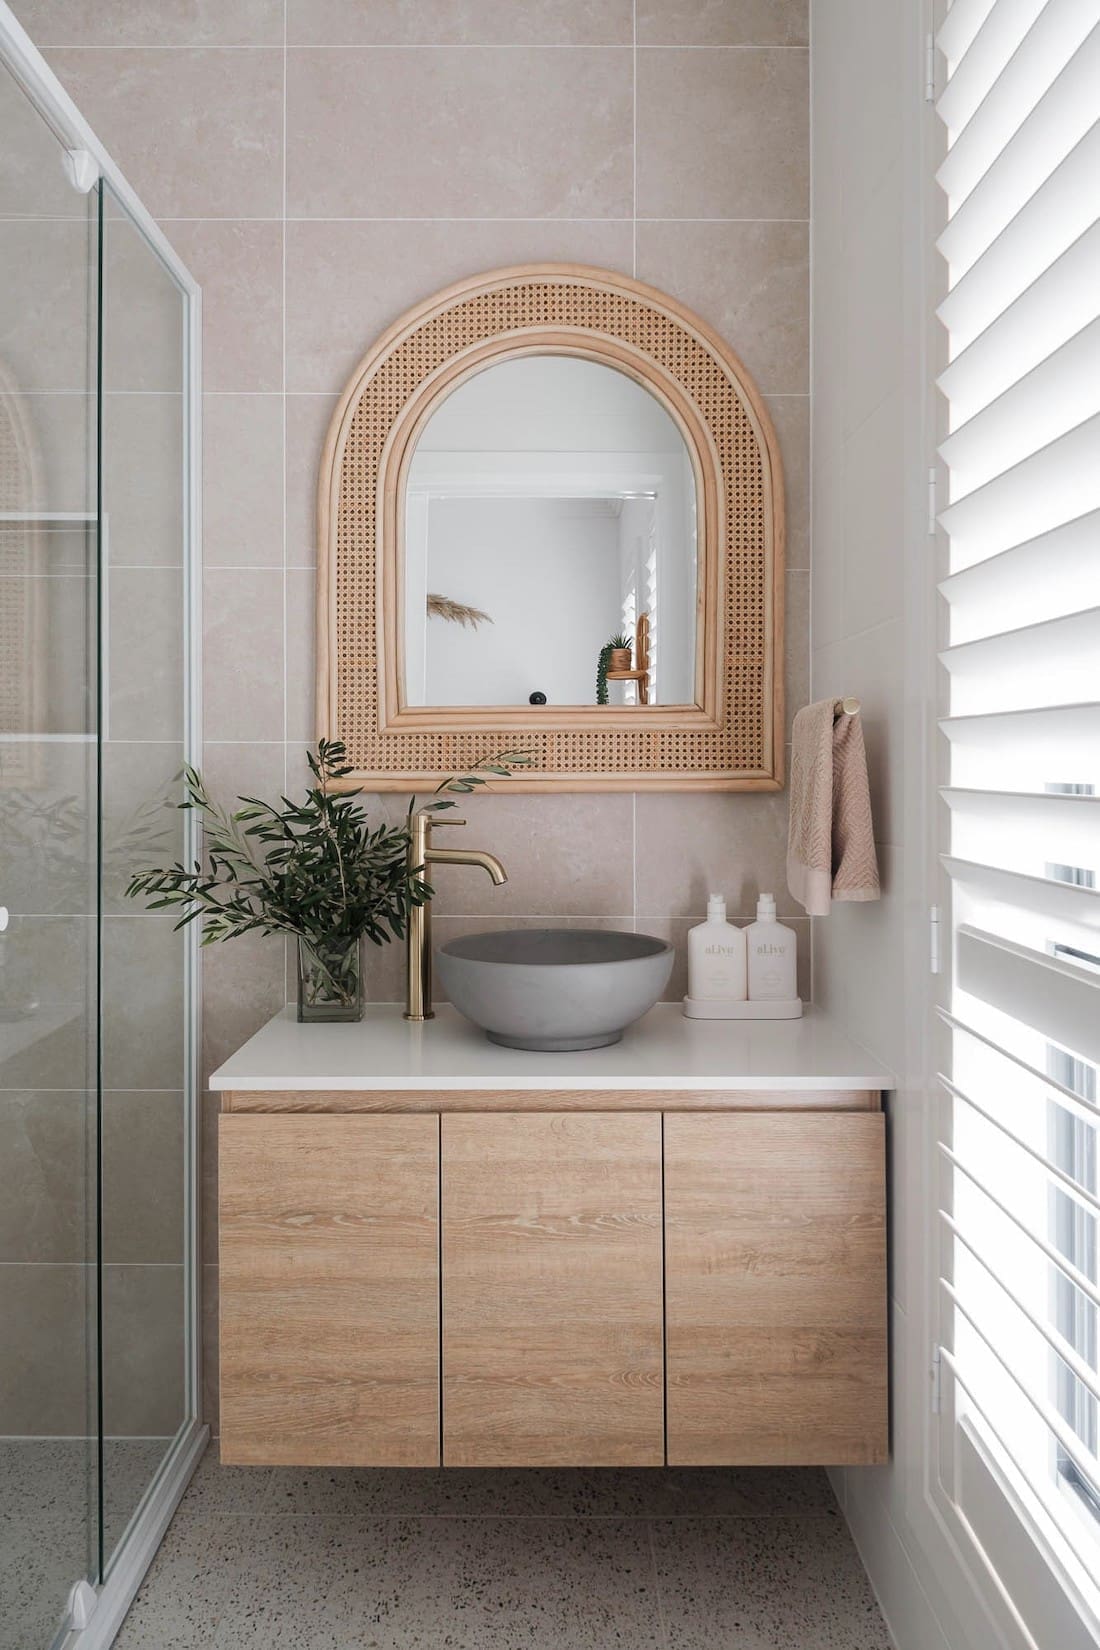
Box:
[811, 0, 1035, 1650]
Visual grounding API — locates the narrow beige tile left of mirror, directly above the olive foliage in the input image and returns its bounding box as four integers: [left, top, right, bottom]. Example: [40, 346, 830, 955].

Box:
[203, 568, 284, 739]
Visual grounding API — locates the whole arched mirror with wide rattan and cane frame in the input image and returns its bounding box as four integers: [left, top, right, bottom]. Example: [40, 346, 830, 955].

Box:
[318, 264, 783, 790]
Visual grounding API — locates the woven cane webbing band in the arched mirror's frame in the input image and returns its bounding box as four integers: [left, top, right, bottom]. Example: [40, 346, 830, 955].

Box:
[320, 271, 782, 789]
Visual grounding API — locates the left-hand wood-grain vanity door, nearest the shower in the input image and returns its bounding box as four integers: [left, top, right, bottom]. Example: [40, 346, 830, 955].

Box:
[219, 1114, 439, 1467]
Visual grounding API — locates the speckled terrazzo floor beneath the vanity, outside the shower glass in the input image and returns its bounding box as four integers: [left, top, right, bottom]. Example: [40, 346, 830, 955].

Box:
[107, 1447, 891, 1650]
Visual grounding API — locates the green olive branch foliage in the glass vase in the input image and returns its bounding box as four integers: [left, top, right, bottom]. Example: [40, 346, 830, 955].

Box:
[125, 739, 531, 945]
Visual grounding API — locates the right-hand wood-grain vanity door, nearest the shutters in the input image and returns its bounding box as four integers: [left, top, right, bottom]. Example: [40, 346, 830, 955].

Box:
[665, 1112, 887, 1465]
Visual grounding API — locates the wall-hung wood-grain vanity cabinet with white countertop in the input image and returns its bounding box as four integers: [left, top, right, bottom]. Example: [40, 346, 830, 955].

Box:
[213, 1005, 889, 1467]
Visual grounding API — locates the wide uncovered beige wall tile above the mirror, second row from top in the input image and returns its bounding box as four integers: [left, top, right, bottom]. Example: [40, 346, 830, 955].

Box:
[287, 48, 632, 218]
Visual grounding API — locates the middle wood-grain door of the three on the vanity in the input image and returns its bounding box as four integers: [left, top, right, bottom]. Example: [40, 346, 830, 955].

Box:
[442, 1112, 665, 1467]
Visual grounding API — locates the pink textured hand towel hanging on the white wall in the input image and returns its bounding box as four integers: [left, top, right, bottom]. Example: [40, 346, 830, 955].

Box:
[787, 700, 879, 917]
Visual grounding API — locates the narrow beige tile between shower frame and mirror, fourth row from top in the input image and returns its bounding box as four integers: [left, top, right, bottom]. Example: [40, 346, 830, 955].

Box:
[203, 396, 284, 568]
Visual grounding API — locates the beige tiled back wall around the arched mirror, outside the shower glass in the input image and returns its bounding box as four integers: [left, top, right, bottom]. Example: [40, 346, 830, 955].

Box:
[16, 0, 814, 1425]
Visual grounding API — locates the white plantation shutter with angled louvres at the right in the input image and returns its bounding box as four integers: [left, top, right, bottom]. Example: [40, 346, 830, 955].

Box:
[937, 0, 1100, 1650]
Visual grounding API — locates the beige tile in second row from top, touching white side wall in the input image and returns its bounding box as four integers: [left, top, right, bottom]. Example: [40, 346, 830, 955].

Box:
[638, 50, 810, 218]
